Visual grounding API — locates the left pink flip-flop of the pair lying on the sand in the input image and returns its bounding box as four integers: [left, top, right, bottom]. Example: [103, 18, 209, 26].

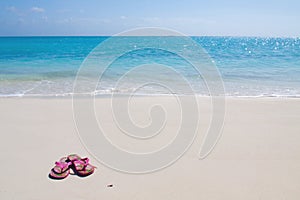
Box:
[49, 158, 72, 179]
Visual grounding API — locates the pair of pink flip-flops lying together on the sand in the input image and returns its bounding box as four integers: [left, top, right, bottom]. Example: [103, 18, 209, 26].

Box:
[49, 154, 96, 179]
